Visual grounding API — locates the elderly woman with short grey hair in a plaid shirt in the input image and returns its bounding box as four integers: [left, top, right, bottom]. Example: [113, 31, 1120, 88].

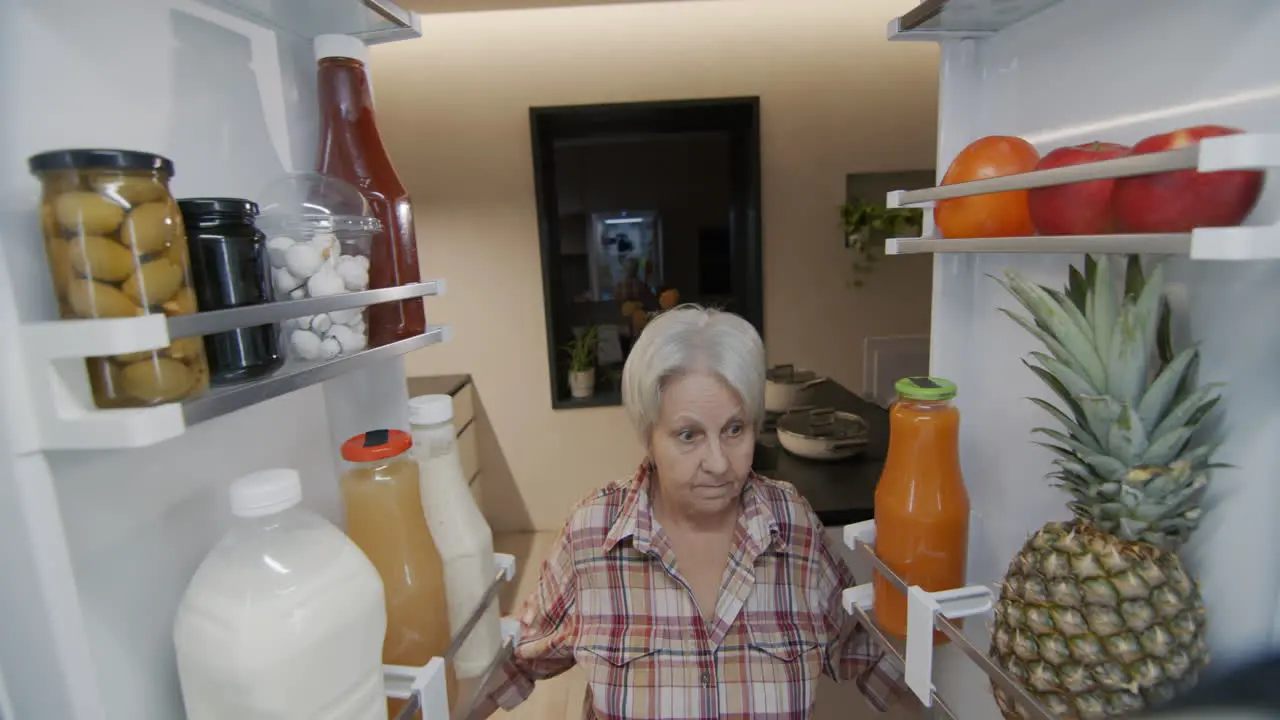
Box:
[472, 305, 895, 720]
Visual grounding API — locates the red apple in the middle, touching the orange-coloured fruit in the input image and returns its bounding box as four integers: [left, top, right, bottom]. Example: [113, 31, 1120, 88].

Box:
[1027, 142, 1129, 234]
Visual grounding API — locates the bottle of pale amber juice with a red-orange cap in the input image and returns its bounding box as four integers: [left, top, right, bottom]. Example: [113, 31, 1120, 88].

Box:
[340, 430, 457, 717]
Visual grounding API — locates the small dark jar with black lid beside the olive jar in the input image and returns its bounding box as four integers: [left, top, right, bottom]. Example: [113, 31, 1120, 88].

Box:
[178, 197, 284, 384]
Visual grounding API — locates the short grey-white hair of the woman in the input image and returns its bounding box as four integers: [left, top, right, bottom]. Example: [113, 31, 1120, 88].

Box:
[622, 305, 764, 445]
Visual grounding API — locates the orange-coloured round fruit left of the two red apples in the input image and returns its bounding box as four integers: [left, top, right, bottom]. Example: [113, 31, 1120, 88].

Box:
[933, 135, 1039, 237]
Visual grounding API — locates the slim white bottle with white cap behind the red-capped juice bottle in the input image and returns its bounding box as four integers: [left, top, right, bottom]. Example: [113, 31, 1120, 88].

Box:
[408, 395, 502, 678]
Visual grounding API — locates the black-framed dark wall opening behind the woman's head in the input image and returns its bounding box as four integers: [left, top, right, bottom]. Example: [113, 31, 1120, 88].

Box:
[529, 97, 764, 409]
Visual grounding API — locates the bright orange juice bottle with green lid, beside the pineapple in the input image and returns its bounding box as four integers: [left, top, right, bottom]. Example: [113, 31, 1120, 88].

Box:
[873, 378, 969, 643]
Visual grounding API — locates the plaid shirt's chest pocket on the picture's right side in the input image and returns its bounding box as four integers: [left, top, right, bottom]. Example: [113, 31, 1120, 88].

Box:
[746, 619, 823, 712]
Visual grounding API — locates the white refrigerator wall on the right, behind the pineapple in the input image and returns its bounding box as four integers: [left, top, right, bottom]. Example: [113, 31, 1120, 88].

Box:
[932, 0, 1280, 717]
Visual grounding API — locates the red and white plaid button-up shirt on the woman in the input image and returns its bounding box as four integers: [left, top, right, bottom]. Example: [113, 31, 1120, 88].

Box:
[472, 465, 900, 720]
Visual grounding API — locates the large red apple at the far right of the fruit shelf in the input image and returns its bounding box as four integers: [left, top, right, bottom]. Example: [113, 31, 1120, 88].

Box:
[1111, 126, 1263, 232]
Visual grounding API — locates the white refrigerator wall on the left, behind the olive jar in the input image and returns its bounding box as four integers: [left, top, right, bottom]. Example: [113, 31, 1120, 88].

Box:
[0, 0, 404, 720]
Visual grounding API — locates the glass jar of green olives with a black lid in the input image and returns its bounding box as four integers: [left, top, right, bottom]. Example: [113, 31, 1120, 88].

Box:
[27, 150, 209, 407]
